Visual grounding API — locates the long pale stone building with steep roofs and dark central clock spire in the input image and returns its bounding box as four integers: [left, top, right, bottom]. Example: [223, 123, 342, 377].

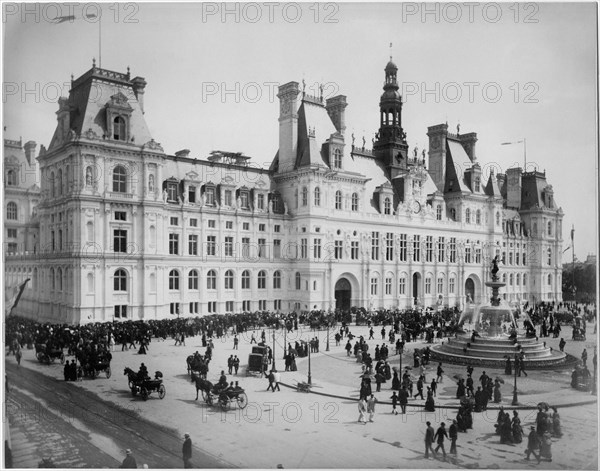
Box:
[4, 61, 563, 323]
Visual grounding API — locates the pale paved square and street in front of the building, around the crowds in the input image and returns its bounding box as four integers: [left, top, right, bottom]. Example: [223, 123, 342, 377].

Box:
[2, 326, 598, 469]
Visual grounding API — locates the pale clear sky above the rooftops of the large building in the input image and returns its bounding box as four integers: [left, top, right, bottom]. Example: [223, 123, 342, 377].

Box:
[2, 2, 598, 261]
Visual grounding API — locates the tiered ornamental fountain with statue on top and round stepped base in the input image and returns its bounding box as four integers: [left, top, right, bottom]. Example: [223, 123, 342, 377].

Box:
[431, 257, 567, 369]
